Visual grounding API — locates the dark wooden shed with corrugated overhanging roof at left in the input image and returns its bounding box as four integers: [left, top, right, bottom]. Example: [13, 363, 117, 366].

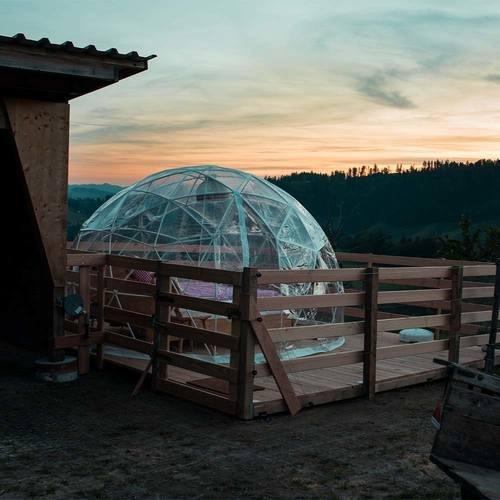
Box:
[0, 34, 155, 360]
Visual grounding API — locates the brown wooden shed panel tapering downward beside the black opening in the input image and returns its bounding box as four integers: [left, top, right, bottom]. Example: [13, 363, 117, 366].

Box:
[4, 97, 69, 361]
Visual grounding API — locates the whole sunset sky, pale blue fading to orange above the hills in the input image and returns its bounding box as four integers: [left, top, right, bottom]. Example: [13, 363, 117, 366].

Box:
[0, 0, 500, 184]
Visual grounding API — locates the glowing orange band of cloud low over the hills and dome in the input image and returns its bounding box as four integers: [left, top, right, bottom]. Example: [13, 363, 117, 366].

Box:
[70, 102, 500, 184]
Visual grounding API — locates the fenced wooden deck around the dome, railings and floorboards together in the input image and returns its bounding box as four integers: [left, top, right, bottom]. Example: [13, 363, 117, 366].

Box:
[64, 254, 500, 419]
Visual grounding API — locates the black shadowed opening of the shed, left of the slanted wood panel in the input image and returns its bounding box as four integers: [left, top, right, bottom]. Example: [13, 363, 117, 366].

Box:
[0, 129, 52, 351]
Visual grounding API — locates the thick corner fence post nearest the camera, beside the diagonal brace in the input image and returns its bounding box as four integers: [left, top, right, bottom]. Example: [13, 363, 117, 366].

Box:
[229, 267, 257, 420]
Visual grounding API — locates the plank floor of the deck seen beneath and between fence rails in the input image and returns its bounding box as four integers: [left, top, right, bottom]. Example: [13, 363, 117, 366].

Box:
[105, 332, 500, 416]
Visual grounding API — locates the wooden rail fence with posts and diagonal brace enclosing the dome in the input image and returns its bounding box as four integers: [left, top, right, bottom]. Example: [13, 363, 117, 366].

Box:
[60, 253, 496, 419]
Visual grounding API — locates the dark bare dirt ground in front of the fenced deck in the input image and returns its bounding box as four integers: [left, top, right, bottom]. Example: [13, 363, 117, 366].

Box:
[0, 347, 459, 500]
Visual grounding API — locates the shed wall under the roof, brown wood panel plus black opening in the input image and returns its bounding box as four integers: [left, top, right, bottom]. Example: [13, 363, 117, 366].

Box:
[0, 98, 69, 355]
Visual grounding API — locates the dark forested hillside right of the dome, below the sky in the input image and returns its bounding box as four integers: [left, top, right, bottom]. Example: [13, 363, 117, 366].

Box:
[267, 160, 500, 255]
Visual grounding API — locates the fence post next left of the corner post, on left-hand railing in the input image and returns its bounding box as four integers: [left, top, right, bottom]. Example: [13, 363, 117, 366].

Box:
[151, 261, 172, 391]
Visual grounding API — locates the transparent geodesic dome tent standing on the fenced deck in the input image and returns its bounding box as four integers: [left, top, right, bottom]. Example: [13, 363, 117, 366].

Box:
[74, 165, 342, 358]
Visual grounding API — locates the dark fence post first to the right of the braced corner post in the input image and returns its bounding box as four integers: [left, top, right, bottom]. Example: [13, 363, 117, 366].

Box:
[363, 267, 378, 399]
